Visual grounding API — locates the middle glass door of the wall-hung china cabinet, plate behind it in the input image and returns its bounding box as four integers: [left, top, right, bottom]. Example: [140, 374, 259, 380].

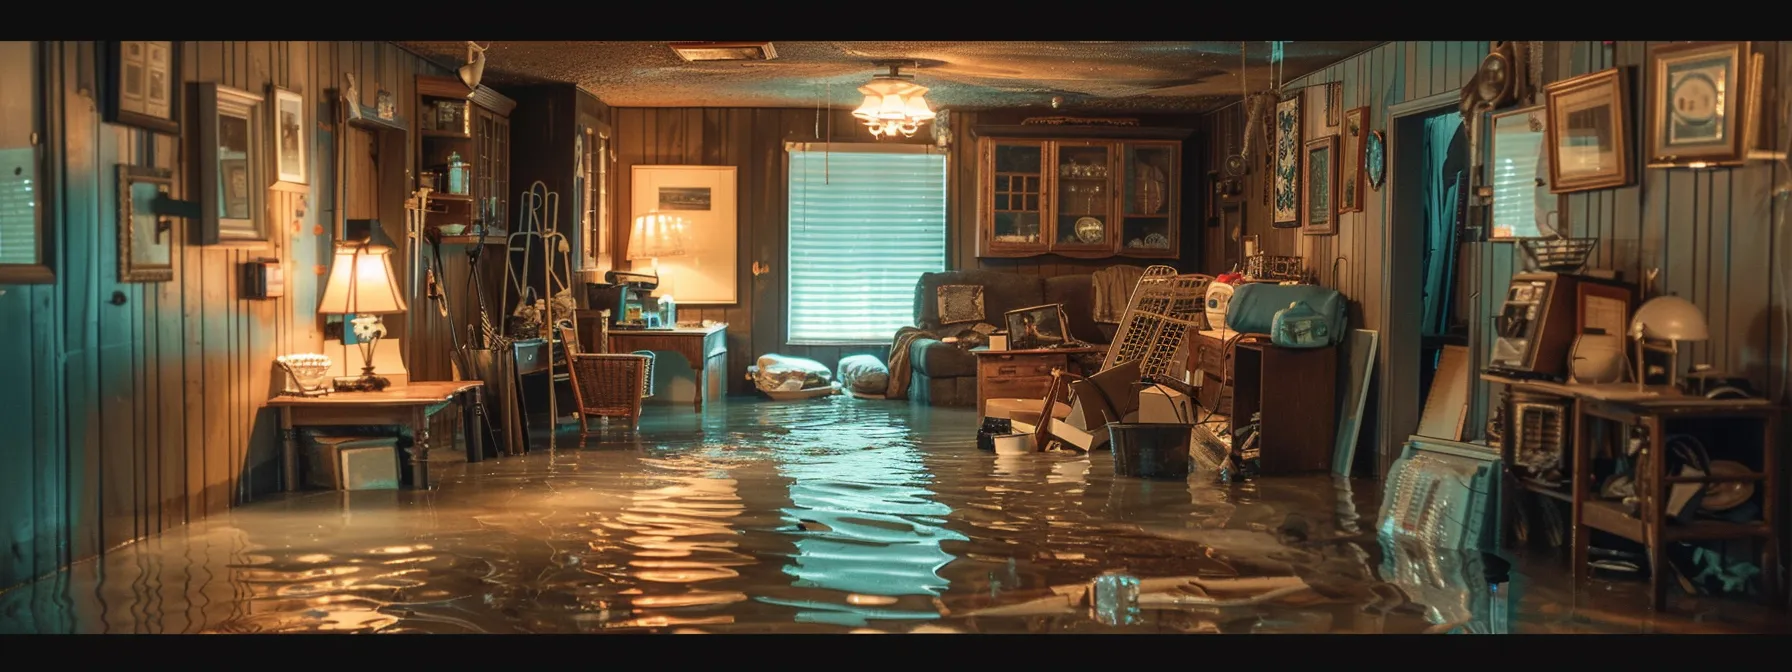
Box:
[1052, 142, 1115, 251]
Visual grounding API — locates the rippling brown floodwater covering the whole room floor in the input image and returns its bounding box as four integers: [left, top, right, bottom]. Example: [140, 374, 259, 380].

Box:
[0, 396, 1785, 634]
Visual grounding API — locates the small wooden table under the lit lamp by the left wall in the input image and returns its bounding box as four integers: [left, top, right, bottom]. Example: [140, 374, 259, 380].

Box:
[267, 380, 484, 493]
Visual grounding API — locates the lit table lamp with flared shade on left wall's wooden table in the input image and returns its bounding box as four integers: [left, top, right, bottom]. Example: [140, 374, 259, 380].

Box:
[317, 220, 405, 392]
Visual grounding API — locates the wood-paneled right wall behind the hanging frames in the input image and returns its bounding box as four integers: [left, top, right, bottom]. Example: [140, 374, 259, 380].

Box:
[1206, 41, 1792, 473]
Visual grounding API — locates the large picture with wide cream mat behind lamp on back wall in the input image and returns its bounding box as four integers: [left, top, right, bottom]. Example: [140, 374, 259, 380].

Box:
[629, 165, 740, 305]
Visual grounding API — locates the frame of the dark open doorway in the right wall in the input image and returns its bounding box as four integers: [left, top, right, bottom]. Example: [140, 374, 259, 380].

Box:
[1374, 91, 1462, 478]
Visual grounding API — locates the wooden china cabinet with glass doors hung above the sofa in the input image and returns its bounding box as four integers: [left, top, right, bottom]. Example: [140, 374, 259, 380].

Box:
[973, 125, 1188, 258]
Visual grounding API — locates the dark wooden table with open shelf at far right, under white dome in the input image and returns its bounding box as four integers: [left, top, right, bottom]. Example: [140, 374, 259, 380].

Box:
[1482, 373, 1779, 611]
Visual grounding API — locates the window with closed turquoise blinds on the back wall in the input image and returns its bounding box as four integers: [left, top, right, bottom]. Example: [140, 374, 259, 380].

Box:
[788, 143, 946, 344]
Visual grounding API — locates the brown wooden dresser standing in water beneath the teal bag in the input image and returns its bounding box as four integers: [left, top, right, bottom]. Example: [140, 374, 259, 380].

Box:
[1188, 332, 1339, 475]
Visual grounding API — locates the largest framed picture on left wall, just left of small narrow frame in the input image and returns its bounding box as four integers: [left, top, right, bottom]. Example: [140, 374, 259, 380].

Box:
[192, 84, 271, 247]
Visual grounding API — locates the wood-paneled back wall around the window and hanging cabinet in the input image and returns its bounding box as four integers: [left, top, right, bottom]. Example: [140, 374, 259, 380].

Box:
[613, 108, 1206, 383]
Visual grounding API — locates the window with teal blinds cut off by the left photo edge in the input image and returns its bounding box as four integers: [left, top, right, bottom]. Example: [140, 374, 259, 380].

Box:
[0, 41, 56, 283]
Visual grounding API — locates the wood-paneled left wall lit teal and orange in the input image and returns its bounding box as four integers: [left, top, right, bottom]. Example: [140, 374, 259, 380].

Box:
[0, 41, 435, 588]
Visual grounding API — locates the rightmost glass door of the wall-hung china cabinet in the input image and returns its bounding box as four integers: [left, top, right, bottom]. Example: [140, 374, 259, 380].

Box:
[1118, 142, 1181, 256]
